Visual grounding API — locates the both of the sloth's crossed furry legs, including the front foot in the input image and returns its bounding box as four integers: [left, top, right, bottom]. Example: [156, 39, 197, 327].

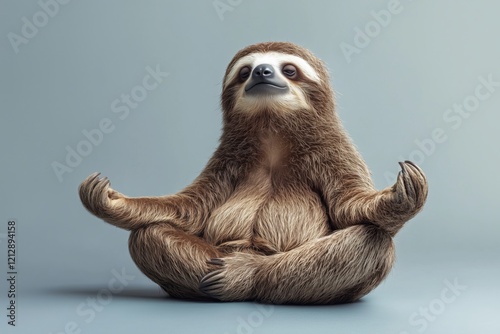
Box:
[129, 224, 394, 304]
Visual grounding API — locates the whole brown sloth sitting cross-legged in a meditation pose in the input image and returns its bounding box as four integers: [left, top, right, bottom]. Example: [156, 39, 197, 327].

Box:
[79, 42, 427, 304]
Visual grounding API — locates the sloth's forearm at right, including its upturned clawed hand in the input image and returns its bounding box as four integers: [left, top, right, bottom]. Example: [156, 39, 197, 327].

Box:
[330, 161, 427, 234]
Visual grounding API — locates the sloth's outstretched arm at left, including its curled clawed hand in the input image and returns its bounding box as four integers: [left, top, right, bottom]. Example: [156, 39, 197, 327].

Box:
[79, 160, 233, 233]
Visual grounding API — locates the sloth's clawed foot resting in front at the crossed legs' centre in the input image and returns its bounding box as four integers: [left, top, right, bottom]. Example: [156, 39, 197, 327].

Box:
[200, 253, 264, 301]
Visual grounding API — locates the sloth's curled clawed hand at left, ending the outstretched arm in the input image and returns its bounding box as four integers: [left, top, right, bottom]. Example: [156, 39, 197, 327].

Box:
[78, 173, 125, 218]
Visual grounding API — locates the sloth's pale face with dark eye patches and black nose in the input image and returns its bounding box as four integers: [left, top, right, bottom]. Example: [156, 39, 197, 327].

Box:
[224, 52, 320, 113]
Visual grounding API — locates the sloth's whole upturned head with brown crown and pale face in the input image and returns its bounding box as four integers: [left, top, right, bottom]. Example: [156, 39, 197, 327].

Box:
[222, 42, 333, 120]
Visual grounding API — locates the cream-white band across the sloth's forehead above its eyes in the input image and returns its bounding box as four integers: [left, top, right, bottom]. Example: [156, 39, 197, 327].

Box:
[224, 52, 320, 88]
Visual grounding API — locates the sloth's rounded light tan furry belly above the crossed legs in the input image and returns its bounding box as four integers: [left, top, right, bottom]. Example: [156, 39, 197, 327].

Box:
[204, 172, 330, 254]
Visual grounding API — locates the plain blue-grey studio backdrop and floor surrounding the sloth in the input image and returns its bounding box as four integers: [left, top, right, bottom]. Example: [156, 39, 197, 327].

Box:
[0, 0, 500, 334]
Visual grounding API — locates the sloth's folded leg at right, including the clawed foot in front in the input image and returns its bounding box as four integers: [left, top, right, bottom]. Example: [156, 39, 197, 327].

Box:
[200, 224, 394, 304]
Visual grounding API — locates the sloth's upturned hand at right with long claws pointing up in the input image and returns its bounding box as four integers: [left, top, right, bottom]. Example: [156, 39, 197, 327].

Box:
[388, 161, 428, 218]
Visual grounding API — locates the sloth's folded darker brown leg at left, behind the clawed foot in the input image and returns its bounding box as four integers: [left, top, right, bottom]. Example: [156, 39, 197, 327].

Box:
[129, 224, 222, 299]
